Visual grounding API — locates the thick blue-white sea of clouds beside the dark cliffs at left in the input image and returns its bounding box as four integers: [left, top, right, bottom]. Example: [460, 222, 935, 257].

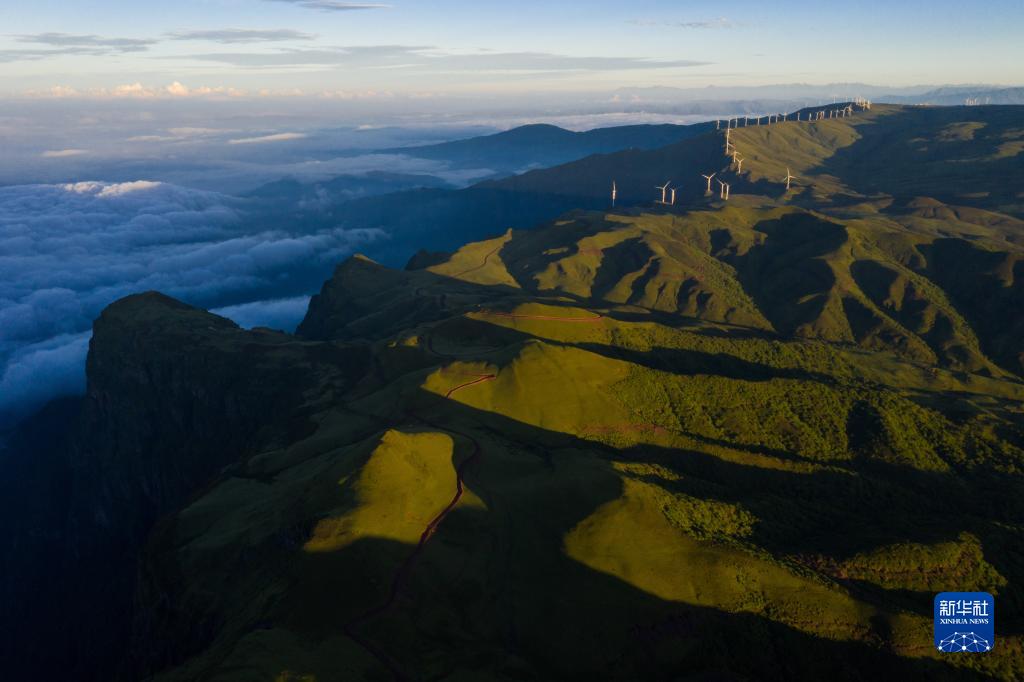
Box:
[0, 181, 385, 427]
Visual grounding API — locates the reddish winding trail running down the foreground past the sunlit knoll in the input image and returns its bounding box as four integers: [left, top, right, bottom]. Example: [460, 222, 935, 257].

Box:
[342, 374, 498, 680]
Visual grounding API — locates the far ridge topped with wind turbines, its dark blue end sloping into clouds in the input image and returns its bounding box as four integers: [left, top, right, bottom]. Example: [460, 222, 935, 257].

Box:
[334, 103, 1024, 265]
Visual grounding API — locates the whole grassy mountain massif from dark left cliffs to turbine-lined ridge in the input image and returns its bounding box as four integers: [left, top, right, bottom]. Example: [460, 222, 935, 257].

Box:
[6, 105, 1024, 682]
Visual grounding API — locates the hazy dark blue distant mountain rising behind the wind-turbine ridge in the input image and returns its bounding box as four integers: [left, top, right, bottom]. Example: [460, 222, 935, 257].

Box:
[387, 123, 714, 173]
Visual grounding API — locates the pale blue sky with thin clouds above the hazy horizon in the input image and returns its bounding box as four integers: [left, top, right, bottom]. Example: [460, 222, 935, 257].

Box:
[0, 0, 1024, 94]
